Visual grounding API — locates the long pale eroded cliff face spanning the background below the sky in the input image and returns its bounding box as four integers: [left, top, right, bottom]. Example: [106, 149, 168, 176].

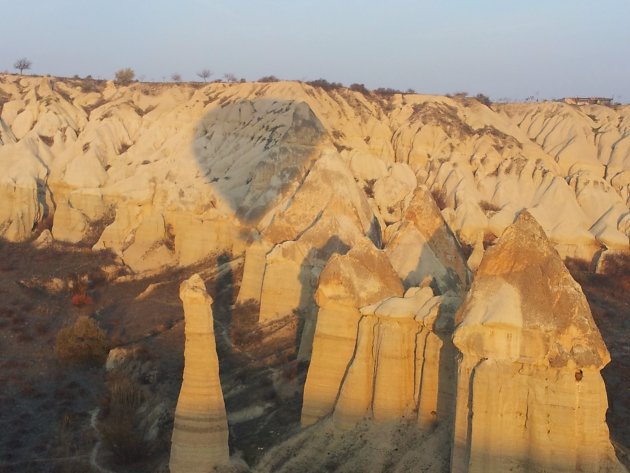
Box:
[0, 76, 630, 270]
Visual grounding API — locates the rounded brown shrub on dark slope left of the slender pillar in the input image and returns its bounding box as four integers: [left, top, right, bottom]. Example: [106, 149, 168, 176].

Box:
[55, 315, 108, 364]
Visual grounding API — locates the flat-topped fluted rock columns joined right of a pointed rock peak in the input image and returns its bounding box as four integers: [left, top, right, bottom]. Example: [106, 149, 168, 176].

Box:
[334, 287, 460, 430]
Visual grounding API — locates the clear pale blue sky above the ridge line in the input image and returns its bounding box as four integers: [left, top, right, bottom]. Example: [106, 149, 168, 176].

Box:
[0, 0, 630, 102]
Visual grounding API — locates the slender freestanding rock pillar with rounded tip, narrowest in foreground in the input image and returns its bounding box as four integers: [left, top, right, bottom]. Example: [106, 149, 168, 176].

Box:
[170, 274, 229, 473]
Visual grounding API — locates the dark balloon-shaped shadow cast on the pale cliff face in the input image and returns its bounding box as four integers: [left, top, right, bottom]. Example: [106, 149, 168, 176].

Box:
[192, 98, 327, 225]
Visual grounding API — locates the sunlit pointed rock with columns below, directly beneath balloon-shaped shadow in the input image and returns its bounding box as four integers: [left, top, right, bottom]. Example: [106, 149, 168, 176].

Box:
[247, 150, 380, 323]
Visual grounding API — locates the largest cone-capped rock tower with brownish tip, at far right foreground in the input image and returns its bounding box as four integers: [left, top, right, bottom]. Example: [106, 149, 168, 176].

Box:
[451, 212, 624, 473]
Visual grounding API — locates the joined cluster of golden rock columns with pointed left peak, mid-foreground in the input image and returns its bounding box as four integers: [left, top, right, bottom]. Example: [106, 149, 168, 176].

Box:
[302, 234, 460, 429]
